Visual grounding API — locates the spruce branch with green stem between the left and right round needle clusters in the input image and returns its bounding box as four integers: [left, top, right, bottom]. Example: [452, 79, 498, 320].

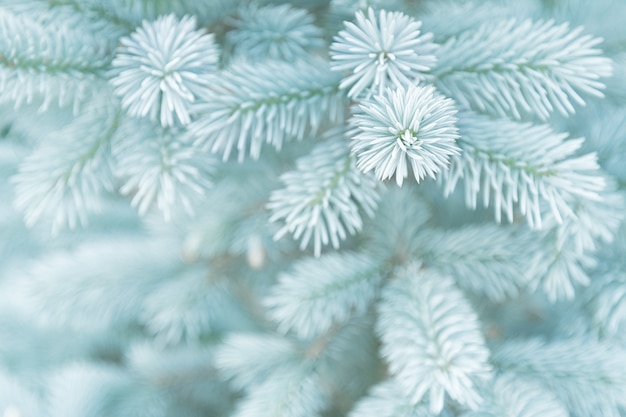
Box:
[188, 61, 344, 161]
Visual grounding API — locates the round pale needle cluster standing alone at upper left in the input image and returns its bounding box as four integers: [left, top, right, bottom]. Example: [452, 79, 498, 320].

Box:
[111, 15, 218, 126]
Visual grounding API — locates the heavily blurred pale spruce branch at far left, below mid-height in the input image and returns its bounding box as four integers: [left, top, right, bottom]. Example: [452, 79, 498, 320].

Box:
[19, 237, 184, 330]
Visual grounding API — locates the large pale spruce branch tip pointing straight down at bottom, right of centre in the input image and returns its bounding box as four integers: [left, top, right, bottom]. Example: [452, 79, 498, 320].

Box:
[376, 264, 491, 414]
